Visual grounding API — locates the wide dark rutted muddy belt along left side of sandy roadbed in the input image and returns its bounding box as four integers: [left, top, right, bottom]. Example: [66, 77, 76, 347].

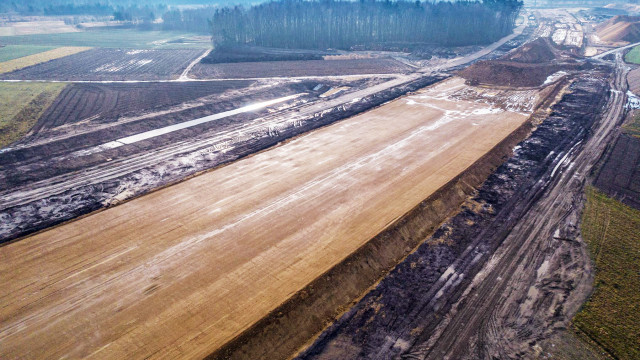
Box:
[0, 77, 438, 241]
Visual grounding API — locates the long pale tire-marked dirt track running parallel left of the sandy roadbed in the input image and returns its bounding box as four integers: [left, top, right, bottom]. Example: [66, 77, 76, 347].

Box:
[0, 75, 417, 209]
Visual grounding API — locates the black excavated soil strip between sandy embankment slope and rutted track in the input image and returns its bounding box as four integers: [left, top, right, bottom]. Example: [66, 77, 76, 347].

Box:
[299, 73, 608, 359]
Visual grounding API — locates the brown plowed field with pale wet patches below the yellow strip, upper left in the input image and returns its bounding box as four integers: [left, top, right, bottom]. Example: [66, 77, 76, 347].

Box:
[0, 49, 203, 81]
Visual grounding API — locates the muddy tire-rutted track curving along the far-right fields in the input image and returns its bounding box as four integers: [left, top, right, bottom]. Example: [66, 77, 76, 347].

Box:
[422, 54, 626, 359]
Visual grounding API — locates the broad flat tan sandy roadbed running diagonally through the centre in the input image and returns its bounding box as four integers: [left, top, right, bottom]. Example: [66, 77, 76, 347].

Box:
[0, 79, 527, 359]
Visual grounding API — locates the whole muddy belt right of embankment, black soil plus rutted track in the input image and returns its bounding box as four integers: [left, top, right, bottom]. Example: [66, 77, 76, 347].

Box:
[300, 64, 624, 359]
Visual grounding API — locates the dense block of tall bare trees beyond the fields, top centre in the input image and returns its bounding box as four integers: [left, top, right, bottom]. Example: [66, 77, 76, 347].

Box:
[198, 0, 522, 49]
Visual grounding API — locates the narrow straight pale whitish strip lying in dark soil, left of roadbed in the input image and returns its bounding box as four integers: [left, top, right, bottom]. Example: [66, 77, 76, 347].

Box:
[100, 93, 306, 148]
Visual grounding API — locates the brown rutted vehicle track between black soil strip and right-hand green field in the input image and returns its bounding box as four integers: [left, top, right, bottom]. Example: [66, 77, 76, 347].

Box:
[420, 53, 626, 359]
